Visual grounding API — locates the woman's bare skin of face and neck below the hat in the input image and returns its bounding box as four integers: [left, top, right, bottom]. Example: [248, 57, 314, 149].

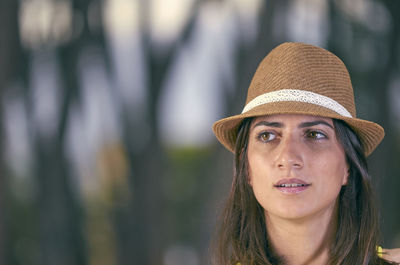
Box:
[248, 114, 349, 265]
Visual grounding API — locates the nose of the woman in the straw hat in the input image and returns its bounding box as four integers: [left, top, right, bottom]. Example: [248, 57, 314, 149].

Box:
[275, 136, 304, 170]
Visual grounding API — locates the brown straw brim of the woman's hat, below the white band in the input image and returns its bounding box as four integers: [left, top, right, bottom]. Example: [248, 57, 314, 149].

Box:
[212, 101, 385, 156]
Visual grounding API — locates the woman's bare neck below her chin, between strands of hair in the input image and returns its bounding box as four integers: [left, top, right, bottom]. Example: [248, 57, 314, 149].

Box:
[266, 206, 337, 265]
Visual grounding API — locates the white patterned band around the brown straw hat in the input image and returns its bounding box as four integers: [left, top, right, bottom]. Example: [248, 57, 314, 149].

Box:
[242, 89, 352, 118]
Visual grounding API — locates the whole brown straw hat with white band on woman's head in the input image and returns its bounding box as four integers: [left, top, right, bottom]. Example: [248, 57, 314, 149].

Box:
[213, 43, 385, 155]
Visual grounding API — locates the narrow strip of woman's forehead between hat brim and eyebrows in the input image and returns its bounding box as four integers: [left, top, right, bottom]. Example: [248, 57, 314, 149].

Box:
[252, 114, 333, 126]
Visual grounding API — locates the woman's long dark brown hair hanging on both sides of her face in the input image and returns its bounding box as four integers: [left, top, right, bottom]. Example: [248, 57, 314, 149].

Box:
[213, 118, 383, 265]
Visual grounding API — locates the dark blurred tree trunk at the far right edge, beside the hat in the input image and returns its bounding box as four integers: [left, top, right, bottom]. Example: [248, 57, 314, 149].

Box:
[376, 0, 400, 244]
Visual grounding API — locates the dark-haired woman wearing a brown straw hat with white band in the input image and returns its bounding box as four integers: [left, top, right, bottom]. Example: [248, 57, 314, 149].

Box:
[213, 43, 398, 265]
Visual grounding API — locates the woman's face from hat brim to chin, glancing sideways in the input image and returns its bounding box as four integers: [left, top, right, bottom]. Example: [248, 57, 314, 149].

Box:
[247, 114, 348, 220]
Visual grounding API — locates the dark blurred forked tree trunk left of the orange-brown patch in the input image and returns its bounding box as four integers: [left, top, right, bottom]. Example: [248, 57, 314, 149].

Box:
[28, 0, 105, 265]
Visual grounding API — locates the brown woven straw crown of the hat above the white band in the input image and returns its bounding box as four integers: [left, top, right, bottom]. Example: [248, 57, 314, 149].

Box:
[246, 42, 356, 117]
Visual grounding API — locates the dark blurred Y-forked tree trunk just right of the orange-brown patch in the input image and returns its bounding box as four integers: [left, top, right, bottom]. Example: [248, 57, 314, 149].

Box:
[115, 1, 199, 265]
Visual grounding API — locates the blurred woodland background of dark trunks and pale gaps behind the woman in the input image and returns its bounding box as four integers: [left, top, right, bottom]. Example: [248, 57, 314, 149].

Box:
[0, 0, 400, 265]
